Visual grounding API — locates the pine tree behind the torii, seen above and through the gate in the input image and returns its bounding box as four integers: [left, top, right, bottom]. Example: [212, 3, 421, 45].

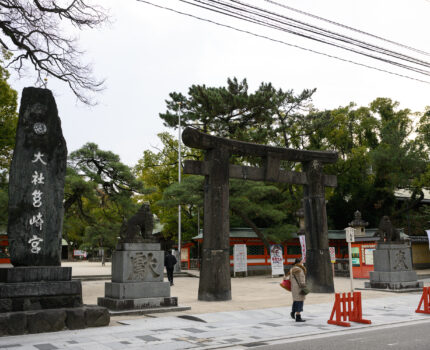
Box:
[155, 78, 316, 242]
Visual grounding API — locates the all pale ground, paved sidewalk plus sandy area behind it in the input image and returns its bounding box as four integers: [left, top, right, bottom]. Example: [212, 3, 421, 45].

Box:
[0, 262, 430, 350]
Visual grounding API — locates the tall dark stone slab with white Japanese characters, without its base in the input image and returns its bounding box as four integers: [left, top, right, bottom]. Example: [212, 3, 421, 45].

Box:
[8, 88, 67, 266]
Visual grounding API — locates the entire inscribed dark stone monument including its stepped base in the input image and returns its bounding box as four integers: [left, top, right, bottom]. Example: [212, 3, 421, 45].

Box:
[0, 88, 109, 336]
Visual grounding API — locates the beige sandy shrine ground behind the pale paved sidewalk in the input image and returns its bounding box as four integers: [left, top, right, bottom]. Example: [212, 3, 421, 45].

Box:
[63, 261, 430, 325]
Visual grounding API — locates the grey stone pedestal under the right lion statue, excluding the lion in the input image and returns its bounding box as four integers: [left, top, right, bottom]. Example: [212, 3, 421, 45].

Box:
[365, 243, 423, 291]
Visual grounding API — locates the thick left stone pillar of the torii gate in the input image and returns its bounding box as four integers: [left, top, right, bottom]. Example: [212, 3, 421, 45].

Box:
[198, 147, 231, 301]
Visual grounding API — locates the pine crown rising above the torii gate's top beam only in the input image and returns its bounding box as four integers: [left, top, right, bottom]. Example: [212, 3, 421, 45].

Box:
[160, 78, 315, 147]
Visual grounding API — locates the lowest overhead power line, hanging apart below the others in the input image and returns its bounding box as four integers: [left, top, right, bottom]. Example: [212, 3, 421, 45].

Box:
[136, 0, 430, 84]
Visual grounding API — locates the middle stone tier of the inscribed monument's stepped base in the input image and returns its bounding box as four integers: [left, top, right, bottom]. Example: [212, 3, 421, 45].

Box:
[0, 281, 82, 299]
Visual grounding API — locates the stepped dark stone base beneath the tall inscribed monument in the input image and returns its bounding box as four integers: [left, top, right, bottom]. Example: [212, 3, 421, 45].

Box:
[0, 266, 110, 336]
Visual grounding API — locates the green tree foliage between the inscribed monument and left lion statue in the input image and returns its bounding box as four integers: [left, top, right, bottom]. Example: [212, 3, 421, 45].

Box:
[63, 143, 149, 254]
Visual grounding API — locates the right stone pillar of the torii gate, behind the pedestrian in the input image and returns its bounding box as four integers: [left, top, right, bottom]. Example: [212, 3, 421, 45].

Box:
[303, 160, 334, 293]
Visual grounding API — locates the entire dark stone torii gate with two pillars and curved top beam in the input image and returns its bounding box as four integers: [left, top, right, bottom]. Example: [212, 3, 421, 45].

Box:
[182, 128, 337, 301]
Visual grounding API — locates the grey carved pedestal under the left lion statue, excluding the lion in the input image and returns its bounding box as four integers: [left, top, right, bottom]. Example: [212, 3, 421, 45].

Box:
[97, 243, 190, 311]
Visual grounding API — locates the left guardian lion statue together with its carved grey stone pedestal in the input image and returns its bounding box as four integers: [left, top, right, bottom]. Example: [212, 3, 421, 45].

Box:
[97, 203, 190, 314]
